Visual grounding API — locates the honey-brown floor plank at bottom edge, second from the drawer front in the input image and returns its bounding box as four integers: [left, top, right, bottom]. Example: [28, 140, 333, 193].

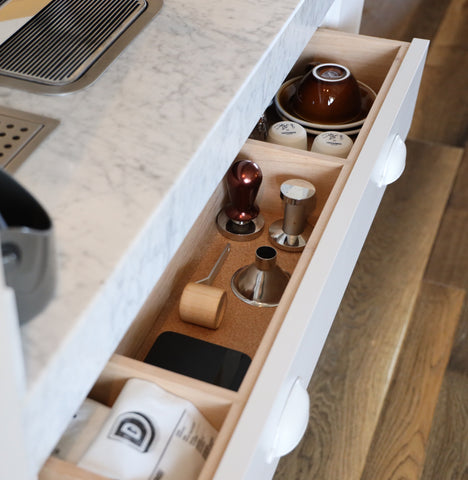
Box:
[361, 282, 465, 480]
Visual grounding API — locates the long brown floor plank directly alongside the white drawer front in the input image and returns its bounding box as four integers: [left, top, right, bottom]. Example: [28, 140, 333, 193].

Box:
[275, 142, 461, 480]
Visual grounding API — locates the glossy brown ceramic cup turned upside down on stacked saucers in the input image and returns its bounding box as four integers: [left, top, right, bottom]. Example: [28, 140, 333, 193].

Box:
[292, 63, 361, 124]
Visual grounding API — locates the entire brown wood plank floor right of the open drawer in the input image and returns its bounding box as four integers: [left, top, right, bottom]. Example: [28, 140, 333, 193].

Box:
[275, 0, 468, 480]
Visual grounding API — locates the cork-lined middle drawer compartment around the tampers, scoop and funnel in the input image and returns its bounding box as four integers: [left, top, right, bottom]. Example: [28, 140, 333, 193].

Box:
[117, 150, 343, 368]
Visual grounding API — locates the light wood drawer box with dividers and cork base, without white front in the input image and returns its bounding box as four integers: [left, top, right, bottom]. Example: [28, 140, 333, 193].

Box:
[39, 30, 408, 480]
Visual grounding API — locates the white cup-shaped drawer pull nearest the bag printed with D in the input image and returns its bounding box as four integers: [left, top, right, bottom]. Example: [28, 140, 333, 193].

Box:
[268, 377, 310, 462]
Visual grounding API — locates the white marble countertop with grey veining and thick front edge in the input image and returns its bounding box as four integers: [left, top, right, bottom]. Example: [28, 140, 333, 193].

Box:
[0, 0, 332, 469]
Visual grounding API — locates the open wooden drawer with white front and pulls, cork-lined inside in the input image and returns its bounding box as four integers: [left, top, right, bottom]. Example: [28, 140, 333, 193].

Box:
[40, 30, 427, 480]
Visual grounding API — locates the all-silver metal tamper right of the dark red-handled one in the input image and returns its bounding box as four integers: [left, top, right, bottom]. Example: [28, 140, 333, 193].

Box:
[269, 179, 316, 252]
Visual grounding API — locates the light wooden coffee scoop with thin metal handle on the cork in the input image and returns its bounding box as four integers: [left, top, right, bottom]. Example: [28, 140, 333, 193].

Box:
[179, 243, 231, 329]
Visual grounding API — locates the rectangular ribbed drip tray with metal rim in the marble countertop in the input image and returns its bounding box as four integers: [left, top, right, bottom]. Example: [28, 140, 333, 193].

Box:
[0, 0, 162, 94]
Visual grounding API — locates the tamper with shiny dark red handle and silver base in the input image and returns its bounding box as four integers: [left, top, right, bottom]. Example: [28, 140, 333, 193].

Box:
[216, 160, 265, 242]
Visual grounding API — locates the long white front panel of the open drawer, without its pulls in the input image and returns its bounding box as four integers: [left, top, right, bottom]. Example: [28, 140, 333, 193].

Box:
[215, 40, 428, 480]
